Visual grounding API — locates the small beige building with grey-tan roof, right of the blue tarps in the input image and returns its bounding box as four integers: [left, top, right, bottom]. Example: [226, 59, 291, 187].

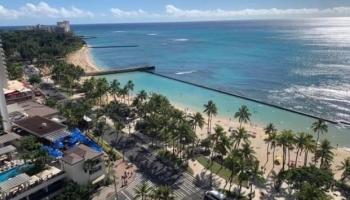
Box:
[61, 144, 105, 185]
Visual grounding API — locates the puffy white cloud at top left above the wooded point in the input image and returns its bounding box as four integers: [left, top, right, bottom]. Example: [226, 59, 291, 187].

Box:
[0, 1, 94, 19]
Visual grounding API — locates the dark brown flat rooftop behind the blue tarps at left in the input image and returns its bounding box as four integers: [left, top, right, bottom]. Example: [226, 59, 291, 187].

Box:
[14, 116, 67, 138]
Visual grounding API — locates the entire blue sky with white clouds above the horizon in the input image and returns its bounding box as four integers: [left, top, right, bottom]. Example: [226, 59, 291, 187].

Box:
[0, 0, 350, 26]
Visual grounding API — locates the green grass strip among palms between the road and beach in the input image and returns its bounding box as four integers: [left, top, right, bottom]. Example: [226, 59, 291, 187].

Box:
[197, 156, 247, 186]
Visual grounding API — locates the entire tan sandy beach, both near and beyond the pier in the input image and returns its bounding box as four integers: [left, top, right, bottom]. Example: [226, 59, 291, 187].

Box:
[67, 46, 350, 179]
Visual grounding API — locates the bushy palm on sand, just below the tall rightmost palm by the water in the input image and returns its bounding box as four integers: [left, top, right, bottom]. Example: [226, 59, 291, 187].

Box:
[315, 139, 334, 169]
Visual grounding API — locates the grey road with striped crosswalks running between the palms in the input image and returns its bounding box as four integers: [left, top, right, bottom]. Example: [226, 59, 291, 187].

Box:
[104, 131, 205, 200]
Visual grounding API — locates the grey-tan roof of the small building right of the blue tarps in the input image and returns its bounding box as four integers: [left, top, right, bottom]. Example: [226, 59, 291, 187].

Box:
[62, 144, 103, 165]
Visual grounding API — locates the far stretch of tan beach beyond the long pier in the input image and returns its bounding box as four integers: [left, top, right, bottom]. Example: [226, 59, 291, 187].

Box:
[66, 45, 100, 72]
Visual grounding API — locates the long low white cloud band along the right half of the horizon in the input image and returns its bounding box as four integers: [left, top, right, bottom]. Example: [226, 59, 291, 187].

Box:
[165, 5, 350, 19]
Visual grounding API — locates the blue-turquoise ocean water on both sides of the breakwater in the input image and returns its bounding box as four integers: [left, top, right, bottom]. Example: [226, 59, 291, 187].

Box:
[73, 18, 350, 146]
